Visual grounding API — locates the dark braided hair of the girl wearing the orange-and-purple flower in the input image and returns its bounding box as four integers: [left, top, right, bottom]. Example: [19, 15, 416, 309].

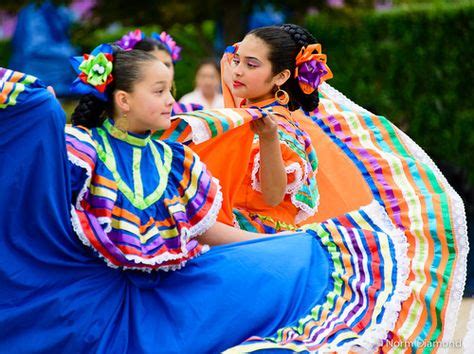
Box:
[247, 24, 319, 111]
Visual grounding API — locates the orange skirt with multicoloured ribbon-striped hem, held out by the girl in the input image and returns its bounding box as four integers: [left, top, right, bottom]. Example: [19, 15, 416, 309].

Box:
[156, 74, 469, 352]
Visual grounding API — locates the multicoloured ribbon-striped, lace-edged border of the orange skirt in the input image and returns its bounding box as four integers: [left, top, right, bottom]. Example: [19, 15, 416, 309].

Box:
[313, 84, 468, 353]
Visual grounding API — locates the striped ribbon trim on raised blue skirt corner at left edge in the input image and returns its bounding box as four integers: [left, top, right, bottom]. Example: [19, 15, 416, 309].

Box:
[0, 67, 38, 109]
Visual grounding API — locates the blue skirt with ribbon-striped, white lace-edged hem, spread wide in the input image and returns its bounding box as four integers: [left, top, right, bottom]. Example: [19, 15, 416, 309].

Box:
[0, 69, 408, 353]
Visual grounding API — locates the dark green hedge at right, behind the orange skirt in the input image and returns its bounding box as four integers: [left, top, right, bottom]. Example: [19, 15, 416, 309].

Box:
[306, 1, 474, 186]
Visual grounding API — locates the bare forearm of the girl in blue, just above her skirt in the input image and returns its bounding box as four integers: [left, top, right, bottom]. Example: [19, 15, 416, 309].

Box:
[197, 221, 265, 246]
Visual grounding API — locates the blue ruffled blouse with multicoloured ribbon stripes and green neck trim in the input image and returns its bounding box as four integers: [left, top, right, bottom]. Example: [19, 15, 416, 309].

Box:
[66, 120, 222, 270]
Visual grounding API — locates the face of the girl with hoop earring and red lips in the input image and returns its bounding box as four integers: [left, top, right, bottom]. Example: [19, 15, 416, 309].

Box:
[231, 35, 286, 103]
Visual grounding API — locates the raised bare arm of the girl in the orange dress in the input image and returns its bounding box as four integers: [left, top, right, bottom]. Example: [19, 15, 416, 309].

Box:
[252, 116, 287, 206]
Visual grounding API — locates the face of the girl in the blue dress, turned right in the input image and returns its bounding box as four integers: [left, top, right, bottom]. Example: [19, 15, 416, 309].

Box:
[123, 60, 174, 133]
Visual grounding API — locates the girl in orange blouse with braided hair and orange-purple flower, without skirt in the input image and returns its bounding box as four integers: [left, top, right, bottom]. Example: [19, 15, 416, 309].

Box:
[209, 25, 332, 233]
